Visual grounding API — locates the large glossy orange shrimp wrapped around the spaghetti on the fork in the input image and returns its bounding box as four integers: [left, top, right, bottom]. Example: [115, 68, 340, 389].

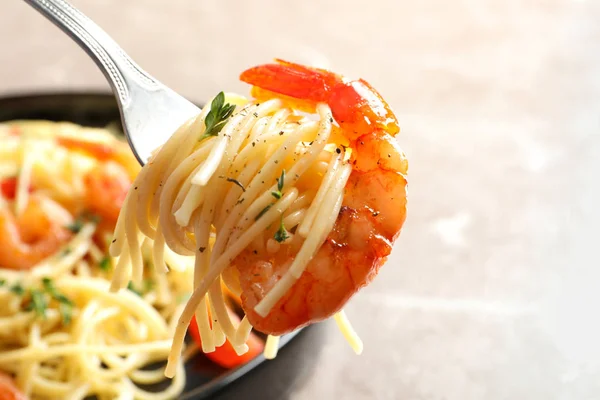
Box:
[232, 61, 408, 335]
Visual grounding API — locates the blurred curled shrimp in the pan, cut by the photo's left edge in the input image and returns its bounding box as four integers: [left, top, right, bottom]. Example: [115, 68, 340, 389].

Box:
[0, 195, 72, 270]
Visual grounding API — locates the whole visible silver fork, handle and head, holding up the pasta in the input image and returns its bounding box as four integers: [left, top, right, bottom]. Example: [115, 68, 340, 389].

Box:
[25, 0, 200, 165]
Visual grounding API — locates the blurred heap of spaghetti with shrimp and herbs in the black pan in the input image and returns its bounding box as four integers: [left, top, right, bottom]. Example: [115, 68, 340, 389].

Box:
[0, 121, 195, 399]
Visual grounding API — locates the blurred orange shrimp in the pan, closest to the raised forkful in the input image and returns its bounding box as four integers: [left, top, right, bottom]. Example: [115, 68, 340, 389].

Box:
[84, 161, 131, 228]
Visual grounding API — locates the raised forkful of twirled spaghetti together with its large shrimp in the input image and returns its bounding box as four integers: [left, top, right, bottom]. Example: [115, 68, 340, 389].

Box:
[110, 62, 406, 377]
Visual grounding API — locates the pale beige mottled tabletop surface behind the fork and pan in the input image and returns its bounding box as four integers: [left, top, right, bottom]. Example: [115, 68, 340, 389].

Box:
[0, 0, 600, 400]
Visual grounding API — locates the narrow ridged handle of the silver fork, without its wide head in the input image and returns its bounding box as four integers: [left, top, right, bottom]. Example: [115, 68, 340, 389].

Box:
[25, 0, 160, 107]
